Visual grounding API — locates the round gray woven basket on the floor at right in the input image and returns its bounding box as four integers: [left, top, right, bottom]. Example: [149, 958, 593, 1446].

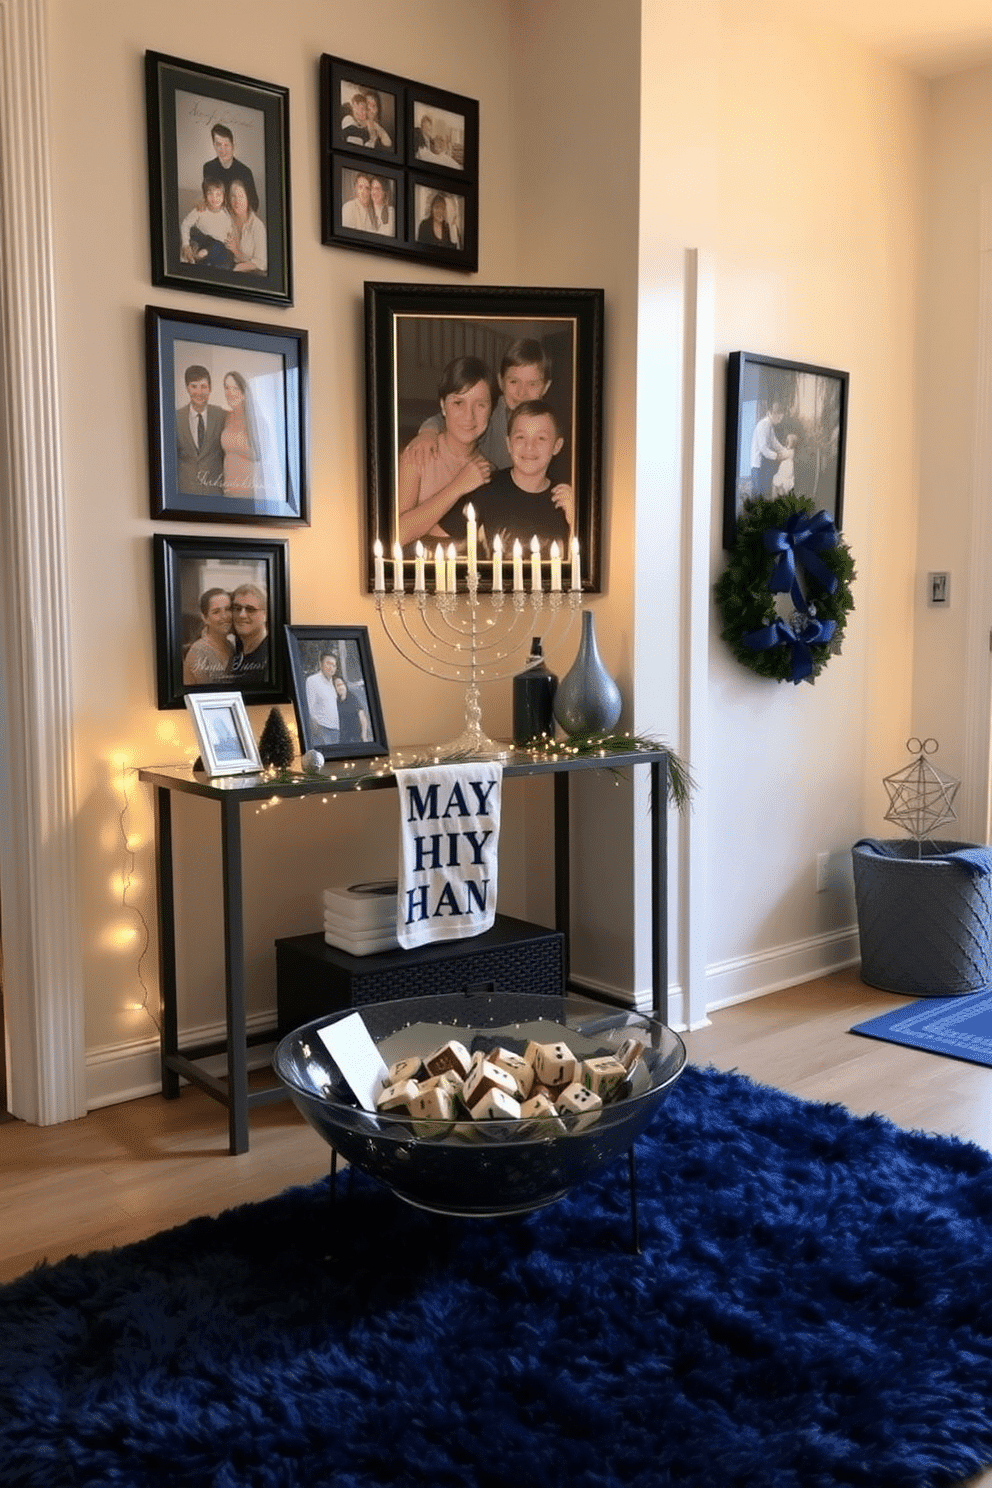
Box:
[851, 839, 992, 997]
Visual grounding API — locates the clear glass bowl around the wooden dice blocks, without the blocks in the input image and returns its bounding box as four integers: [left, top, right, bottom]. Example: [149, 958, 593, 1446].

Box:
[272, 992, 686, 1216]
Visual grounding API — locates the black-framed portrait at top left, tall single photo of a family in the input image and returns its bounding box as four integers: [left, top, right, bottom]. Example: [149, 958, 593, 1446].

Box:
[144, 52, 293, 305]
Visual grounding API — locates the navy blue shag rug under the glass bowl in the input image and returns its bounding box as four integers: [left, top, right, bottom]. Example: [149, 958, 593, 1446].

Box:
[0, 1067, 992, 1488]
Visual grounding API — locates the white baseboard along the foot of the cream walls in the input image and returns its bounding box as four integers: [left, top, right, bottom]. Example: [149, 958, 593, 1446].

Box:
[86, 926, 860, 1110]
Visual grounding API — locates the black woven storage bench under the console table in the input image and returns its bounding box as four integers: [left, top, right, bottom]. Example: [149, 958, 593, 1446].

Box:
[275, 915, 565, 1039]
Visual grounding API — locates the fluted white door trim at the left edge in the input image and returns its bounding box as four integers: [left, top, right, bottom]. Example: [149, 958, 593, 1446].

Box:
[0, 0, 86, 1125]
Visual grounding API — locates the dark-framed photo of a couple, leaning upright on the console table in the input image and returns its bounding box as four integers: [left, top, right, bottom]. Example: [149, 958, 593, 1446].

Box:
[286, 625, 390, 760]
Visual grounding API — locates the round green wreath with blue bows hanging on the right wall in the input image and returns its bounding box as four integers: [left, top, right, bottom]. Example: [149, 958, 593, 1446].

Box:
[714, 491, 855, 683]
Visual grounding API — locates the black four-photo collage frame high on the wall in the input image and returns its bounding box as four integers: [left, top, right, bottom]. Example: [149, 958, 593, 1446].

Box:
[320, 55, 479, 272]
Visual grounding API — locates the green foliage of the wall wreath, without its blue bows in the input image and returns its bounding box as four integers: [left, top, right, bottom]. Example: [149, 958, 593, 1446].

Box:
[714, 491, 855, 682]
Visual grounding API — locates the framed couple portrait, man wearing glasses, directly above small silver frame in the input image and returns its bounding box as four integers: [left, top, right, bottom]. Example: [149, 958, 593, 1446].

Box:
[152, 533, 289, 708]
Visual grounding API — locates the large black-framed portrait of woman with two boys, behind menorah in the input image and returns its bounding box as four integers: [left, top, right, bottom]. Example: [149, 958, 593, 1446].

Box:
[363, 283, 604, 594]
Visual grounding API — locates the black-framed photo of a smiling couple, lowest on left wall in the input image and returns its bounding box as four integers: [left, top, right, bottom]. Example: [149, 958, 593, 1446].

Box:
[152, 533, 290, 708]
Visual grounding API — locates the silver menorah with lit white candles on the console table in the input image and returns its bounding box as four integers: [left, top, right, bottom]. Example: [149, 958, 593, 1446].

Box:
[373, 506, 582, 759]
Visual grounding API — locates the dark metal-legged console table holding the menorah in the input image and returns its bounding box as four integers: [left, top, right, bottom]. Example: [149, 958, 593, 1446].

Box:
[138, 748, 668, 1155]
